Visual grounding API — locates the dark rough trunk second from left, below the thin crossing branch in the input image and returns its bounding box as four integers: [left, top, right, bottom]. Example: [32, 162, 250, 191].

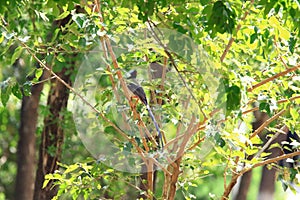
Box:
[34, 68, 71, 200]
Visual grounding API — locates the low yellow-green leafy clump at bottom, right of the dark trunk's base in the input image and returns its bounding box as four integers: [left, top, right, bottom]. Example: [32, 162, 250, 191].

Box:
[44, 159, 138, 199]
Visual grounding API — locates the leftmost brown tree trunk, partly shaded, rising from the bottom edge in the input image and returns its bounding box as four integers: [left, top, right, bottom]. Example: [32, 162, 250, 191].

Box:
[14, 70, 46, 200]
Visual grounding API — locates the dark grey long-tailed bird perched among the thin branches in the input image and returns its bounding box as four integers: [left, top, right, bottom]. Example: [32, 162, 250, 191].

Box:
[127, 70, 164, 149]
